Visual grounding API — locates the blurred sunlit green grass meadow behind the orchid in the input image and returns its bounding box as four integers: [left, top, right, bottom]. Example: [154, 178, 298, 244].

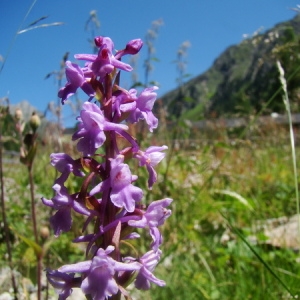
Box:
[0, 121, 300, 299]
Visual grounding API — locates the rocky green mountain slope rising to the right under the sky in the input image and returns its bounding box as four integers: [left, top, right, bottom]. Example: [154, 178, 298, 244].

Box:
[161, 15, 300, 121]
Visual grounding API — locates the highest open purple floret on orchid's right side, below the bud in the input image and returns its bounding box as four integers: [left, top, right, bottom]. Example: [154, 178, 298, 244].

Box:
[128, 86, 158, 132]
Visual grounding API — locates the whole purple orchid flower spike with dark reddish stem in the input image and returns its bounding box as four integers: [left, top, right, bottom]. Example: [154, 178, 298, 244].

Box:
[42, 37, 172, 300]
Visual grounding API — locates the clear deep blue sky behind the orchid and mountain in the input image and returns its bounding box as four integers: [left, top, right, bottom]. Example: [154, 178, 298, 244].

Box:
[0, 0, 300, 125]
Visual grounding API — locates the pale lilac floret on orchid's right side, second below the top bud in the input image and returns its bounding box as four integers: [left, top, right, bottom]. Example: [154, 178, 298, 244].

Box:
[134, 145, 168, 190]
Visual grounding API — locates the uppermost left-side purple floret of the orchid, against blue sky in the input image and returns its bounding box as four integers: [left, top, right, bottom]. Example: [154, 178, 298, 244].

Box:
[58, 61, 95, 104]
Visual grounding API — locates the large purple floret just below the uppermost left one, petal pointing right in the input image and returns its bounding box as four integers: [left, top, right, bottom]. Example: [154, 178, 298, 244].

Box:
[72, 102, 128, 156]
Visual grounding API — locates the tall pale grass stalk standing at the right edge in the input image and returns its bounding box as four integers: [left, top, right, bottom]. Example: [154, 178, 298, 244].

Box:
[276, 60, 300, 241]
